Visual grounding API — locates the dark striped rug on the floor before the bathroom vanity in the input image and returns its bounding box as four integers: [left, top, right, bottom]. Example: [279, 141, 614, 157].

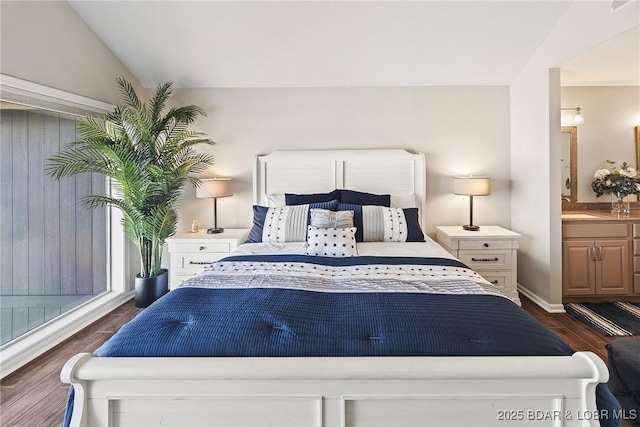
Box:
[564, 302, 640, 336]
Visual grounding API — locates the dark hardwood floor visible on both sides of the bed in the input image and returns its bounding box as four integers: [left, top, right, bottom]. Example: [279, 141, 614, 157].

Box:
[0, 298, 632, 427]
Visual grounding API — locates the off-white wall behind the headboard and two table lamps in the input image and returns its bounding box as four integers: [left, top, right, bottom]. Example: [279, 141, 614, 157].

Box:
[173, 86, 510, 241]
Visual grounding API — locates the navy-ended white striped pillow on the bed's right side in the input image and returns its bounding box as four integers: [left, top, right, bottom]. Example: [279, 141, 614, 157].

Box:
[338, 203, 425, 242]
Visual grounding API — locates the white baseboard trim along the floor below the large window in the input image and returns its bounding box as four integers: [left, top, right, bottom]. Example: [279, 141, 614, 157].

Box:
[0, 292, 133, 378]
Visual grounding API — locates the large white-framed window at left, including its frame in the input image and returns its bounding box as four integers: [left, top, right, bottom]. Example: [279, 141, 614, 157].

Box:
[0, 74, 133, 376]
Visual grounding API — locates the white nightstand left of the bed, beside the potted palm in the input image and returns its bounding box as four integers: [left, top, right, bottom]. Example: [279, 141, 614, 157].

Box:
[167, 229, 251, 289]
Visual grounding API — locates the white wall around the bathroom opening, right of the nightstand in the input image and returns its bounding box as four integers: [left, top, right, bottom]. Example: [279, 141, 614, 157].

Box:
[511, 1, 640, 309]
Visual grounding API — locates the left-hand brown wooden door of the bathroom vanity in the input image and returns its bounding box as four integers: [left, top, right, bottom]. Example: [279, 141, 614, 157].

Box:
[562, 240, 596, 296]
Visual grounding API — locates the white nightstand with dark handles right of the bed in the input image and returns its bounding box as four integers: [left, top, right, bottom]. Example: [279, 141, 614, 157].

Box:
[436, 225, 522, 305]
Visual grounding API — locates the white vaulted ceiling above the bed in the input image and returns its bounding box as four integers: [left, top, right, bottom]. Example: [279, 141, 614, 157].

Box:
[69, 0, 636, 88]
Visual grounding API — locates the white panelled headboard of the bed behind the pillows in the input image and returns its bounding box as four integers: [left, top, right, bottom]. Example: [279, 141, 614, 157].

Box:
[253, 149, 426, 230]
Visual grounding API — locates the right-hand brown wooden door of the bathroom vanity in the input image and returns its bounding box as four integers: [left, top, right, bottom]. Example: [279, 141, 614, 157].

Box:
[595, 239, 631, 295]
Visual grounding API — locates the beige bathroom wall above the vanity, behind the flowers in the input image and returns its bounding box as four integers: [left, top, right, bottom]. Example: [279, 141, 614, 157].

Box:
[561, 86, 640, 203]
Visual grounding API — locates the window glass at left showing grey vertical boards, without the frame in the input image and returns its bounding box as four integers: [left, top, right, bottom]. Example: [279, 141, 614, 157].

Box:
[0, 102, 109, 345]
